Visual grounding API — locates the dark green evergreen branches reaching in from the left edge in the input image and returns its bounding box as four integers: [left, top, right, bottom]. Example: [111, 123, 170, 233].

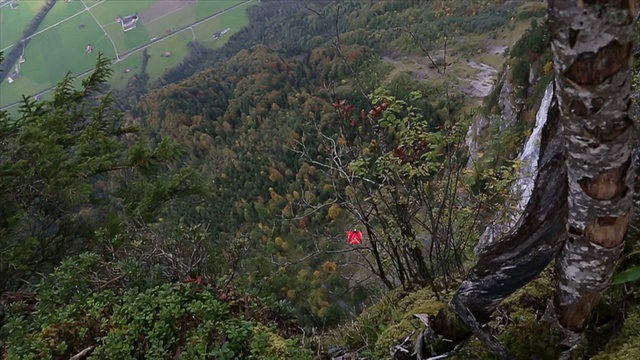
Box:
[0, 57, 202, 291]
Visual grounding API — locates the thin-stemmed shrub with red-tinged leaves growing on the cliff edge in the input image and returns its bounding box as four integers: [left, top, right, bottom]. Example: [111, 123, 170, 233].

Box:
[298, 89, 478, 292]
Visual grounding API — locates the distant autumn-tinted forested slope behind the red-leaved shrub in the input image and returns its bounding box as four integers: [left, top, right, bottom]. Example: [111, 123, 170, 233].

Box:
[125, 1, 552, 330]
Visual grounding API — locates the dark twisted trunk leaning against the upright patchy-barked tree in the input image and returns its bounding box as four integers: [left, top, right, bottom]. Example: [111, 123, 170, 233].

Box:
[433, 86, 567, 353]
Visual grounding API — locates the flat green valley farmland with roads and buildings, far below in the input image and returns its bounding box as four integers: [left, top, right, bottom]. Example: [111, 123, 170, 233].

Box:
[0, 0, 255, 108]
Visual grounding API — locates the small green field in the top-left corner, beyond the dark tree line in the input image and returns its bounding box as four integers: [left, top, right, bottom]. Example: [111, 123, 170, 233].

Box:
[0, 1, 44, 50]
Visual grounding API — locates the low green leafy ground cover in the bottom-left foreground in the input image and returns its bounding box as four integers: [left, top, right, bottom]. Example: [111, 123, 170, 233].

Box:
[3, 254, 310, 359]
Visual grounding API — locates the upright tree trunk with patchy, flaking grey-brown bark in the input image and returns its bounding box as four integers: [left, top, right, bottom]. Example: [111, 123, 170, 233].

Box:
[549, 0, 635, 338]
